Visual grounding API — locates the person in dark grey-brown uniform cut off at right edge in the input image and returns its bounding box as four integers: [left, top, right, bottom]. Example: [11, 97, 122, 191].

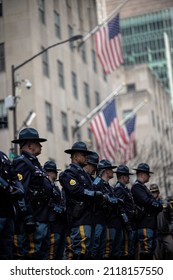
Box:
[150, 184, 173, 260]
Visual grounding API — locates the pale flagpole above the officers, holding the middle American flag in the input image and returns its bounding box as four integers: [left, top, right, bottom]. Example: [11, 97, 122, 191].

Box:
[73, 83, 125, 137]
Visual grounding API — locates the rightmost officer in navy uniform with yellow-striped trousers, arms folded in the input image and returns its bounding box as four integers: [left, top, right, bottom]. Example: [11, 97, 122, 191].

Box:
[131, 163, 162, 260]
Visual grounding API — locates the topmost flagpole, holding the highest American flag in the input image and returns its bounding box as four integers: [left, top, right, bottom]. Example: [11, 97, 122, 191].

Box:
[78, 0, 129, 49]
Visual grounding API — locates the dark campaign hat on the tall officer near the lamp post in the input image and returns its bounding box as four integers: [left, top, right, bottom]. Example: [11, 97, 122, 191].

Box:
[11, 127, 47, 144]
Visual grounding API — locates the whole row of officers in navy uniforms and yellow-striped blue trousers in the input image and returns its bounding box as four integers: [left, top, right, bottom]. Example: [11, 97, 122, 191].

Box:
[0, 128, 172, 260]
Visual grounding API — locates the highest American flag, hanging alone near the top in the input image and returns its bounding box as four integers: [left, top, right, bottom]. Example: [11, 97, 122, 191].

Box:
[94, 15, 123, 74]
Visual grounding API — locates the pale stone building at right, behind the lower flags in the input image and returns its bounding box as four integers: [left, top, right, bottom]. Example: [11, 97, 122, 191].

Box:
[113, 64, 173, 196]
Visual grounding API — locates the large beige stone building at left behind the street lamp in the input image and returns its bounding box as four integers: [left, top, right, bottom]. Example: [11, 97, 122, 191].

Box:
[0, 0, 111, 166]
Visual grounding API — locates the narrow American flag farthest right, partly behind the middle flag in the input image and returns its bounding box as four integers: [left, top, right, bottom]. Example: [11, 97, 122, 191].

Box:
[124, 114, 136, 162]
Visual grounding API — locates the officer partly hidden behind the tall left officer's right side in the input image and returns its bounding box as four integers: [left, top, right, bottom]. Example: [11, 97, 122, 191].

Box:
[44, 160, 67, 260]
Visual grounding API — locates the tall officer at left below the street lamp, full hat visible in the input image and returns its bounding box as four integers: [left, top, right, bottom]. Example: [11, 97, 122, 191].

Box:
[12, 128, 53, 259]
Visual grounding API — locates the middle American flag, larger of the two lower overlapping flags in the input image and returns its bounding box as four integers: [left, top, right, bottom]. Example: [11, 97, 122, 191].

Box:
[90, 99, 127, 162]
